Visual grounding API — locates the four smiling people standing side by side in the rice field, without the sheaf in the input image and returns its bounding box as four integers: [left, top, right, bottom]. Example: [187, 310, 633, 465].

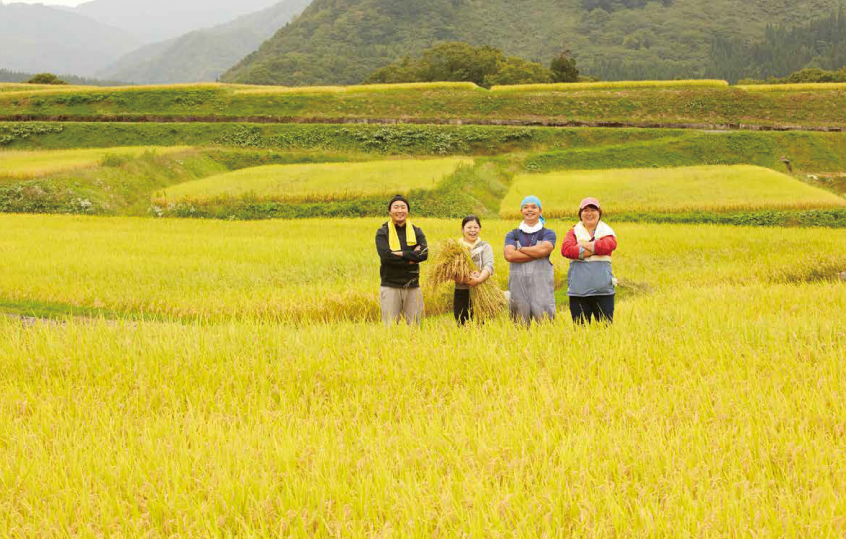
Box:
[376, 195, 617, 325]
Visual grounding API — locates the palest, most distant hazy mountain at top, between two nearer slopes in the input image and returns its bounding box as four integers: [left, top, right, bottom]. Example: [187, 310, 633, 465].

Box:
[69, 0, 279, 43]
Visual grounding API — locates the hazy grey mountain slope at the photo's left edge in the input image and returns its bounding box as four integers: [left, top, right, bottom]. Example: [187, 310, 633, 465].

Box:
[0, 4, 139, 75]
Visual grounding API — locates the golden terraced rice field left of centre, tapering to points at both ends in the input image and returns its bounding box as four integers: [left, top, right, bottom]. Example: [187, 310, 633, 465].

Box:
[157, 157, 473, 206]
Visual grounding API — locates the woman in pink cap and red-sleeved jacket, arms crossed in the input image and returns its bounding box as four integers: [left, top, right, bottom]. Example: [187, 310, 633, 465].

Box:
[561, 197, 617, 324]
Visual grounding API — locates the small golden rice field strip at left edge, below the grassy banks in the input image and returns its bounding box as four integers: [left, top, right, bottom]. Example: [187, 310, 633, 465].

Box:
[0, 146, 190, 179]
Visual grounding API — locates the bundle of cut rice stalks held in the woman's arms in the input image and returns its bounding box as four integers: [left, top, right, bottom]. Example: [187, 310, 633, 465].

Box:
[429, 239, 508, 320]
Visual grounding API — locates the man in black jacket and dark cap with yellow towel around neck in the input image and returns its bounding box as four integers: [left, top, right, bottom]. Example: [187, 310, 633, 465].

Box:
[376, 195, 429, 326]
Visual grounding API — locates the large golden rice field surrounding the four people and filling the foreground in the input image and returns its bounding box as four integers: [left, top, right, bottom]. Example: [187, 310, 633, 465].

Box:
[0, 212, 846, 538]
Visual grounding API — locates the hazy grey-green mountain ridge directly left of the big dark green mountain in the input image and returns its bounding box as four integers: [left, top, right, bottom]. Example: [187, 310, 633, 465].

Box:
[99, 0, 310, 84]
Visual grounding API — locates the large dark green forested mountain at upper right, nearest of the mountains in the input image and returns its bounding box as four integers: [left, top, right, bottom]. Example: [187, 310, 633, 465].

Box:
[222, 0, 840, 85]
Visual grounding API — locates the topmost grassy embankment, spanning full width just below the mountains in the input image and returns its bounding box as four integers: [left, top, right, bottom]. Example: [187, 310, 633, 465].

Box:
[0, 84, 846, 128]
